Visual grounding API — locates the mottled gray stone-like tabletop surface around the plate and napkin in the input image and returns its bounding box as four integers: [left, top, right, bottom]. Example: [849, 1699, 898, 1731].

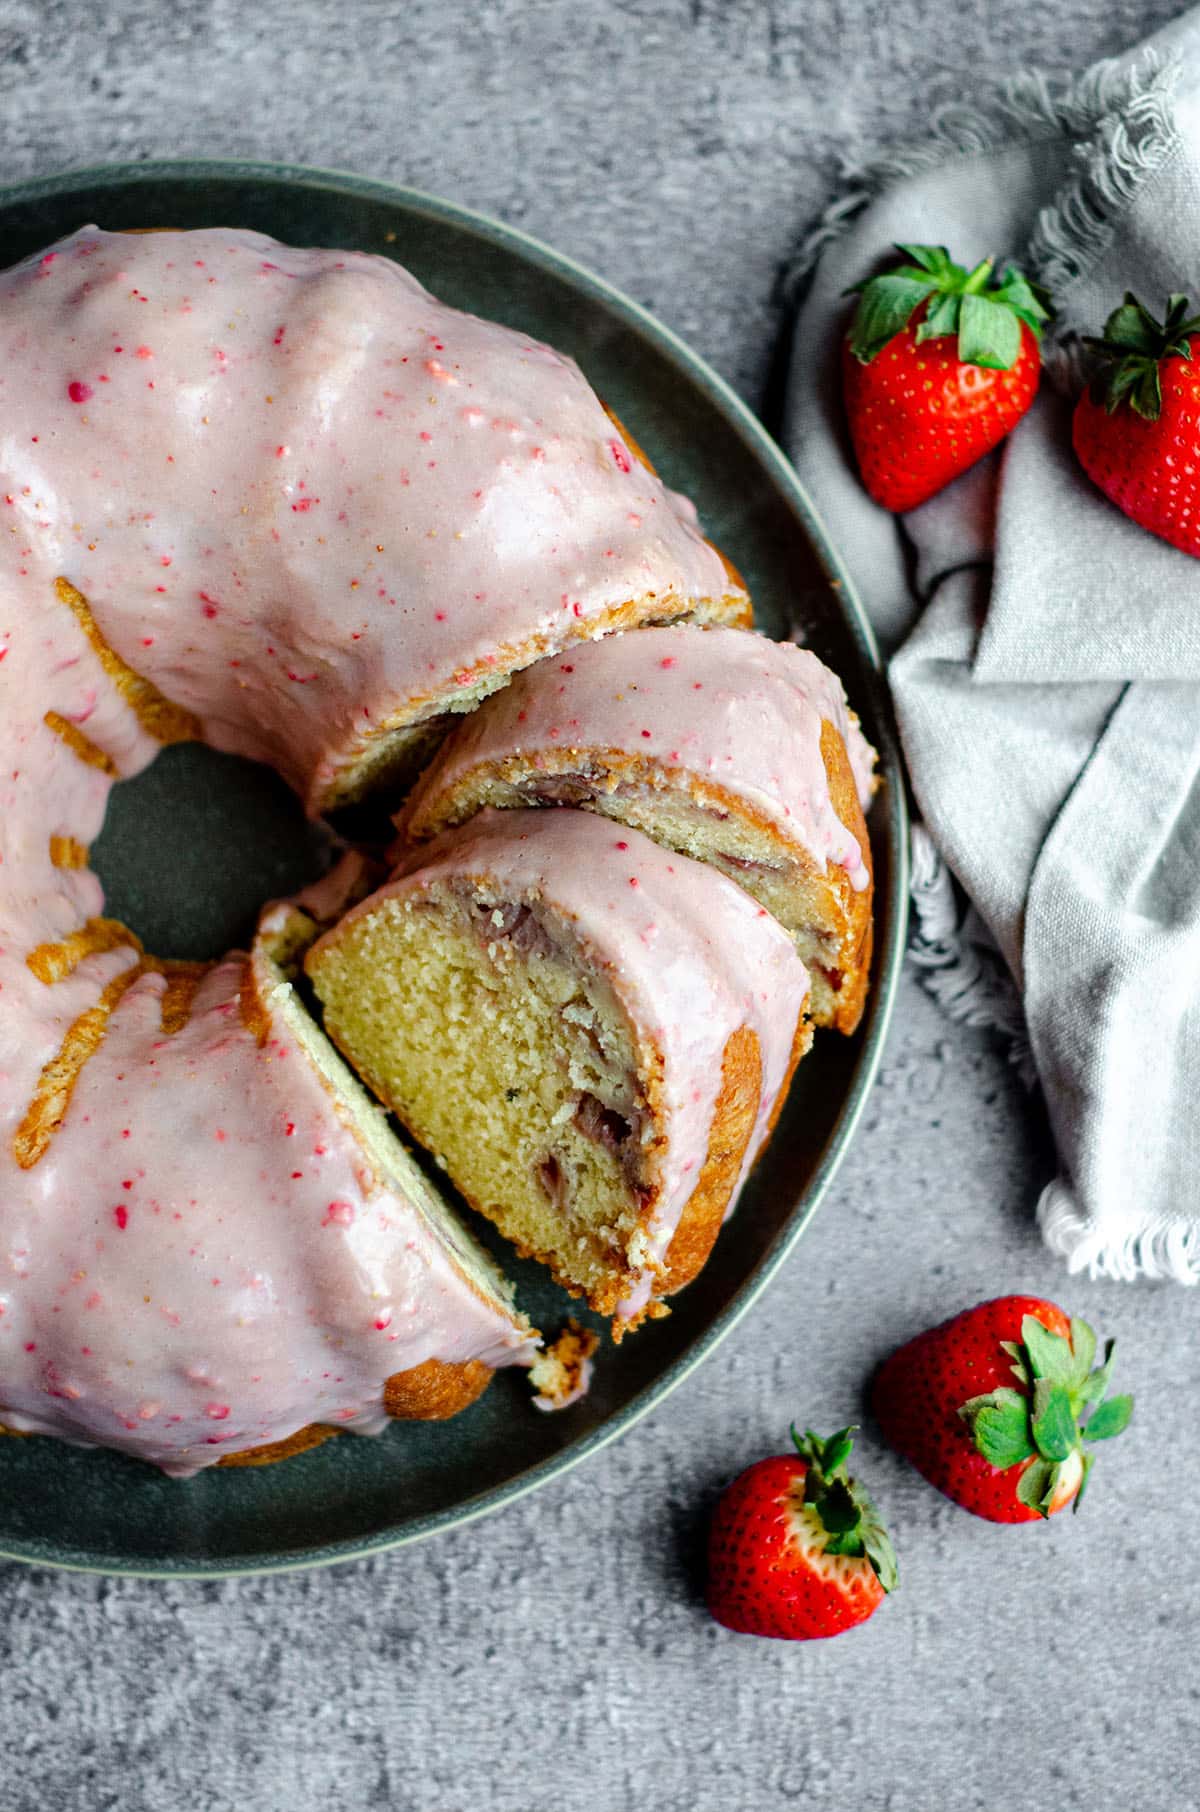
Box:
[0, 0, 1200, 1812]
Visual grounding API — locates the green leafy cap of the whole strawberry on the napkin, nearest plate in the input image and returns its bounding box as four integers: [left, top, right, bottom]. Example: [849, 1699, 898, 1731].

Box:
[847, 245, 1053, 371]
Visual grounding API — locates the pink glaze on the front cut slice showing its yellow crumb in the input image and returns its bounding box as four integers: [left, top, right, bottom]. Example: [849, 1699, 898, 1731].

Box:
[314, 810, 808, 1316]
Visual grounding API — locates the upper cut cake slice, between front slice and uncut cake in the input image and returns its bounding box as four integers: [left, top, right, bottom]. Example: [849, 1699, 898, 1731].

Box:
[397, 625, 874, 1031]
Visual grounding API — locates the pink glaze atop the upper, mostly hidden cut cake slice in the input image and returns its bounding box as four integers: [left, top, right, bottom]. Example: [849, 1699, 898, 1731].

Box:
[399, 623, 876, 888]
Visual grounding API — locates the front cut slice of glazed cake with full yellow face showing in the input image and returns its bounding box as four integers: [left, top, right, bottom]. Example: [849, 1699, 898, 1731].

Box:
[305, 810, 810, 1332]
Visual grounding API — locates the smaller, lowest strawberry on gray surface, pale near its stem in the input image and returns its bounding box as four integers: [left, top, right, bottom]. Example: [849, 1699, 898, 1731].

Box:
[709, 1428, 897, 1642]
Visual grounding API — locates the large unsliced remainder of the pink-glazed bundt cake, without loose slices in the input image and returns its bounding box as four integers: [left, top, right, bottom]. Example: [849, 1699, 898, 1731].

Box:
[0, 228, 761, 1473]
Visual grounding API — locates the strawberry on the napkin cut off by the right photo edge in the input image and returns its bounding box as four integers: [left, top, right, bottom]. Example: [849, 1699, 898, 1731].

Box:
[1071, 292, 1200, 558]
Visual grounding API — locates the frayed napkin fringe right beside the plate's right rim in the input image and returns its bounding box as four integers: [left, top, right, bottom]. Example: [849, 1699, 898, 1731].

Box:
[908, 824, 1037, 1089]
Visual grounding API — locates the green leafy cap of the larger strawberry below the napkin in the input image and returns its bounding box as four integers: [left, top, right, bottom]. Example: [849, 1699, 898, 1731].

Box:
[959, 1316, 1133, 1517]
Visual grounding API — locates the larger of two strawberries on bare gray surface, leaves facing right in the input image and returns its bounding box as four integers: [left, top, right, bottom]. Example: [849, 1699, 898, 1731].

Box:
[872, 1296, 1133, 1522]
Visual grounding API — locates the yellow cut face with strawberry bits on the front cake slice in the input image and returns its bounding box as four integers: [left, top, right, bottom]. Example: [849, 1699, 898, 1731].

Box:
[310, 882, 660, 1314]
